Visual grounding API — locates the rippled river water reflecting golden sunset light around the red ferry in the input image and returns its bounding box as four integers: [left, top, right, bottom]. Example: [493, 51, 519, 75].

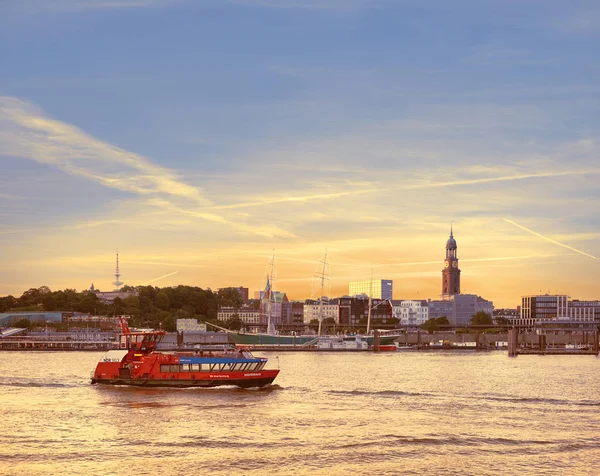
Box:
[0, 351, 600, 475]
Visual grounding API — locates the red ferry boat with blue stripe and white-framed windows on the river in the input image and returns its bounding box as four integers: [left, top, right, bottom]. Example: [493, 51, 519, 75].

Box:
[92, 318, 279, 388]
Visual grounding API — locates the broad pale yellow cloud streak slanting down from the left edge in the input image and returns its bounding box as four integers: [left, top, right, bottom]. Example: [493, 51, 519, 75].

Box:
[0, 97, 292, 236]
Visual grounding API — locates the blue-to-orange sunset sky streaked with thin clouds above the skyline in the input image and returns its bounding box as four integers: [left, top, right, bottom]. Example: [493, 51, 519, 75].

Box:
[0, 0, 600, 307]
